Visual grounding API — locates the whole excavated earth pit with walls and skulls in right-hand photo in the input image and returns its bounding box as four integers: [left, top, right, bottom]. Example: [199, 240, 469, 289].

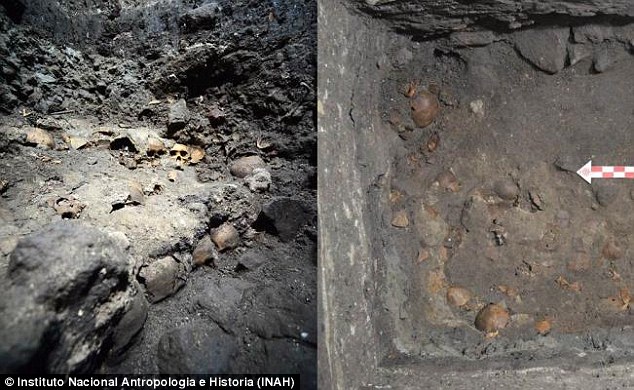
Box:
[318, 0, 634, 389]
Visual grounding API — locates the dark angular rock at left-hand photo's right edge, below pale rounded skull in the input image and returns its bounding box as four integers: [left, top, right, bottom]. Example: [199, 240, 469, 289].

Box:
[256, 198, 310, 242]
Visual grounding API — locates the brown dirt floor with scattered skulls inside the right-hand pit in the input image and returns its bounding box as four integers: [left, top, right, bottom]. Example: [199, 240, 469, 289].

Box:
[376, 25, 634, 359]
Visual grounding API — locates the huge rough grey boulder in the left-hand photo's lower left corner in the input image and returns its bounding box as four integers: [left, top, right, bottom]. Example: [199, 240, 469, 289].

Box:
[0, 221, 145, 373]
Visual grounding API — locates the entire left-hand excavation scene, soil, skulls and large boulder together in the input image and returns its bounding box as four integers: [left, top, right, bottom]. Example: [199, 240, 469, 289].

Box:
[0, 0, 317, 388]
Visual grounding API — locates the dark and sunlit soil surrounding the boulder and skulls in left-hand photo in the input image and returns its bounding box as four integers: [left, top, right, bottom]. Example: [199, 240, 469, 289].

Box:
[0, 0, 317, 388]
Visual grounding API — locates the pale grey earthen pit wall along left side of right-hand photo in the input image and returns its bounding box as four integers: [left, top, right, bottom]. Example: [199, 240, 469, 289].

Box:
[318, 1, 398, 389]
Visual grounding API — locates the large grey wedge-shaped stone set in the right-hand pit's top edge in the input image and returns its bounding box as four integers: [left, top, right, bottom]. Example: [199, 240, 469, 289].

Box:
[515, 28, 570, 74]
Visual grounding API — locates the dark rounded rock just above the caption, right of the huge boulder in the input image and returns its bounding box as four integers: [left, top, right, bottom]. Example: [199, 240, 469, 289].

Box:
[157, 323, 238, 375]
